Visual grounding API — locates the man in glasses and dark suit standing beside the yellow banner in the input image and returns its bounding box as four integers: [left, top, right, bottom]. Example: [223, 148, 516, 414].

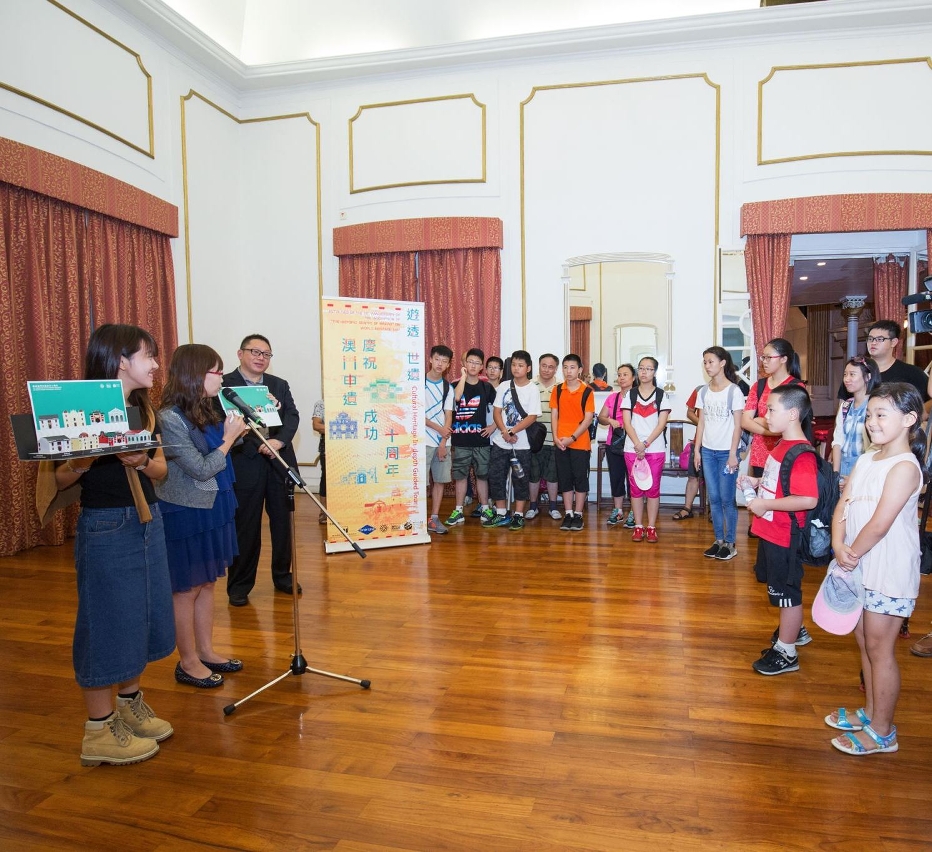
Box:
[223, 334, 301, 606]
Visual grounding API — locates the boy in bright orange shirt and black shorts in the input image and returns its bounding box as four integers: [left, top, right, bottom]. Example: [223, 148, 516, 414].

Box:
[550, 355, 595, 532]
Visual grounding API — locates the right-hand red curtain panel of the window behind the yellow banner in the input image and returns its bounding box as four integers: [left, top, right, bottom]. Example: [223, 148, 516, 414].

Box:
[418, 248, 504, 362]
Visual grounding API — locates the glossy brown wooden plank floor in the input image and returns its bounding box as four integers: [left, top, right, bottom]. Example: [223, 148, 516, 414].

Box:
[0, 498, 932, 852]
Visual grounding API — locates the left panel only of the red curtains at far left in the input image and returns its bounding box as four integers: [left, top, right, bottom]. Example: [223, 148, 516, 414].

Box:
[0, 183, 90, 556]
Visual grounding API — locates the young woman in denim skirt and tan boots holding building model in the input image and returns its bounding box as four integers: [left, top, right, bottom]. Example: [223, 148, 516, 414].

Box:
[55, 324, 175, 766]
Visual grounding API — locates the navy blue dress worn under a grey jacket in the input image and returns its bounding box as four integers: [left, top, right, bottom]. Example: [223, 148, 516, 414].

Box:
[159, 423, 239, 592]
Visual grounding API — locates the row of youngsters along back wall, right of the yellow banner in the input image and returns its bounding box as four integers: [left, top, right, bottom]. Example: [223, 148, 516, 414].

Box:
[425, 346, 670, 532]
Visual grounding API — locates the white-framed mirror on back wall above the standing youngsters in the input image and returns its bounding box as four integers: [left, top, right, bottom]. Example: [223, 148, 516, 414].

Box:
[564, 253, 673, 384]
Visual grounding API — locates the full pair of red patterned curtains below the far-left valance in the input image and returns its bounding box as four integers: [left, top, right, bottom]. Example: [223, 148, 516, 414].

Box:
[0, 183, 177, 555]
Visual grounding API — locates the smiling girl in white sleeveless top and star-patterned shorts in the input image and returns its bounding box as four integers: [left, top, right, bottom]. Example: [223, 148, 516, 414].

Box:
[825, 382, 925, 755]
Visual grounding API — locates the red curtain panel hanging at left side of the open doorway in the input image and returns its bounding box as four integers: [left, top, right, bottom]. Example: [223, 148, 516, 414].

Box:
[744, 234, 792, 354]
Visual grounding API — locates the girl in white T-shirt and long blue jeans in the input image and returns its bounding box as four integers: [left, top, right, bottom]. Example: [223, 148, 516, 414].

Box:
[693, 346, 744, 560]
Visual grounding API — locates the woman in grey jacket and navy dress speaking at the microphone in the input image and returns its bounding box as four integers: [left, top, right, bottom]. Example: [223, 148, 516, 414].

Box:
[156, 343, 248, 689]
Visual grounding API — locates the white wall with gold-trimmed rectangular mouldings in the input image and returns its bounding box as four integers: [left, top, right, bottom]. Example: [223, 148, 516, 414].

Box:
[0, 0, 932, 452]
